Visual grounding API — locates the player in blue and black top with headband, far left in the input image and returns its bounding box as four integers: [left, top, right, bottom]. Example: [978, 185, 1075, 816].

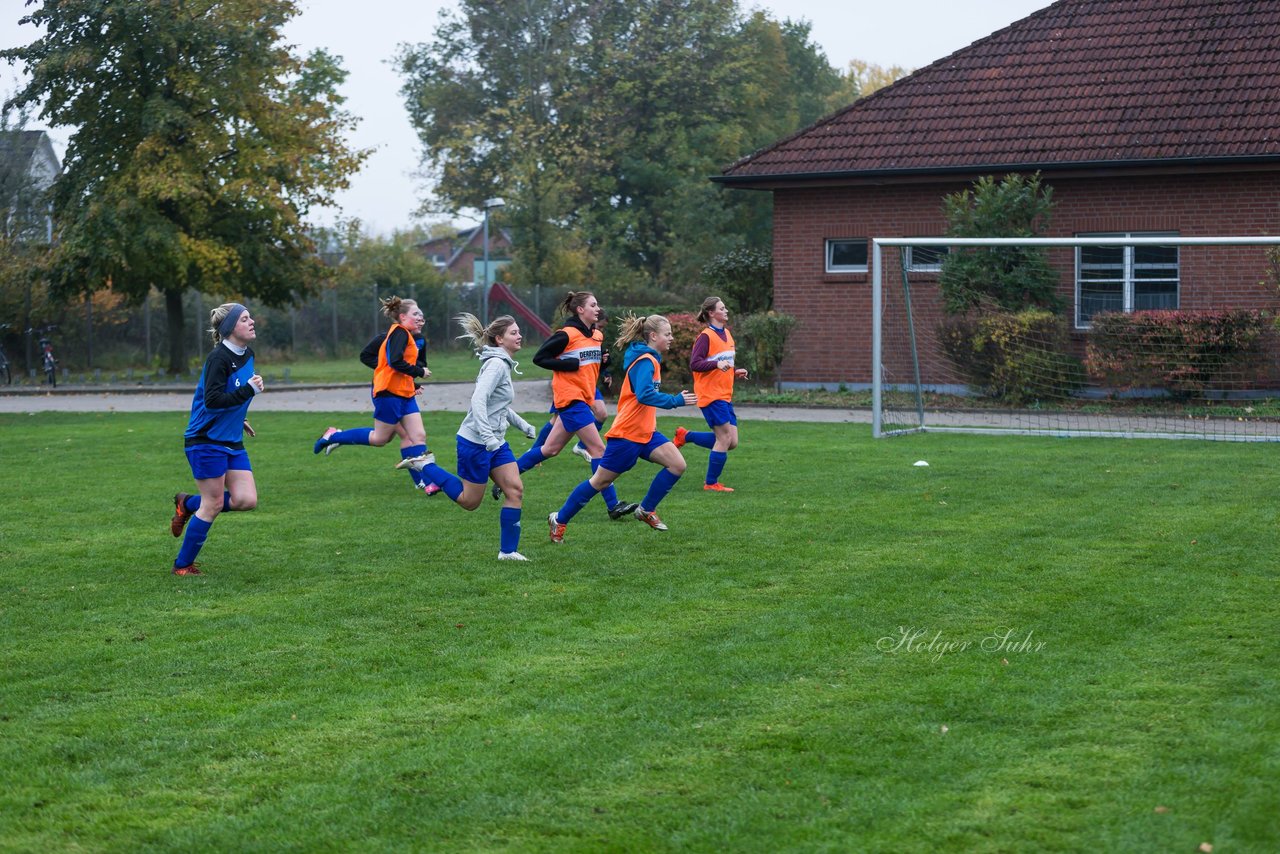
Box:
[169, 302, 262, 575]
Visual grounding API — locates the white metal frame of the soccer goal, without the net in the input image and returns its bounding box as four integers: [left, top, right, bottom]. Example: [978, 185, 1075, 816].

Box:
[870, 234, 1280, 442]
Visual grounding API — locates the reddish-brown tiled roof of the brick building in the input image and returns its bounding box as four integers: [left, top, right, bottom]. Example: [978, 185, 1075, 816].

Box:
[718, 0, 1280, 183]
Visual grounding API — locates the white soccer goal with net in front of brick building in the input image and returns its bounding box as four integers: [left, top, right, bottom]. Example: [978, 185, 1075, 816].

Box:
[870, 234, 1280, 442]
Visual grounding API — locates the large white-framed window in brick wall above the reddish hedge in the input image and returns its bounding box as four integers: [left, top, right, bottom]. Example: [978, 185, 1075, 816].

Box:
[1075, 232, 1179, 329]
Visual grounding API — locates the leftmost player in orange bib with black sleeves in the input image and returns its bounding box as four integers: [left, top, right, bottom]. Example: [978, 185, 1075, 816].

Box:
[312, 297, 431, 471]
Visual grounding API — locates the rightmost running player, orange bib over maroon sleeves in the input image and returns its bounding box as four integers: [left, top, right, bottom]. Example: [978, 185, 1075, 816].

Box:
[672, 297, 746, 492]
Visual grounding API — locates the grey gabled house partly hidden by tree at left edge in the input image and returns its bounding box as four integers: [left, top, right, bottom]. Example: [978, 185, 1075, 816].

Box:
[0, 131, 63, 243]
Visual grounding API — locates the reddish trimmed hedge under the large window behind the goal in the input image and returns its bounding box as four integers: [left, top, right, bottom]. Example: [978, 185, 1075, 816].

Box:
[1084, 309, 1270, 397]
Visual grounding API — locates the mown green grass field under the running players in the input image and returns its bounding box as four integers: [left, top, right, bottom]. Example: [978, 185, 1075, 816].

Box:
[0, 412, 1280, 853]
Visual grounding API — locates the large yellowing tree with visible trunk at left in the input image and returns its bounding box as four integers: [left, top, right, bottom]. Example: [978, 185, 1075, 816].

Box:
[0, 0, 365, 370]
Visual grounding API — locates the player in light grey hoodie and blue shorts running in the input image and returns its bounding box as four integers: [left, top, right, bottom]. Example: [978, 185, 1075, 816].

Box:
[396, 314, 536, 561]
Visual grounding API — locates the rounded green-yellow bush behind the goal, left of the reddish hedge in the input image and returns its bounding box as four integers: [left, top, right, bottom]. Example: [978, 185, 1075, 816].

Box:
[938, 309, 1084, 406]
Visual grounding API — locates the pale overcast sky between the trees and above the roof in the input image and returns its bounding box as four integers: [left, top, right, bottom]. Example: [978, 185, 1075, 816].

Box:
[0, 0, 1051, 233]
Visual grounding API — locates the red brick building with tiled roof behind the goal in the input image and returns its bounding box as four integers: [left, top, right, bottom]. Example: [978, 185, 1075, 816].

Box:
[714, 0, 1280, 385]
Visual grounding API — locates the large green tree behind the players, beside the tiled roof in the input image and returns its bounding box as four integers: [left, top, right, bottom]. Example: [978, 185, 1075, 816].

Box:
[398, 0, 841, 294]
